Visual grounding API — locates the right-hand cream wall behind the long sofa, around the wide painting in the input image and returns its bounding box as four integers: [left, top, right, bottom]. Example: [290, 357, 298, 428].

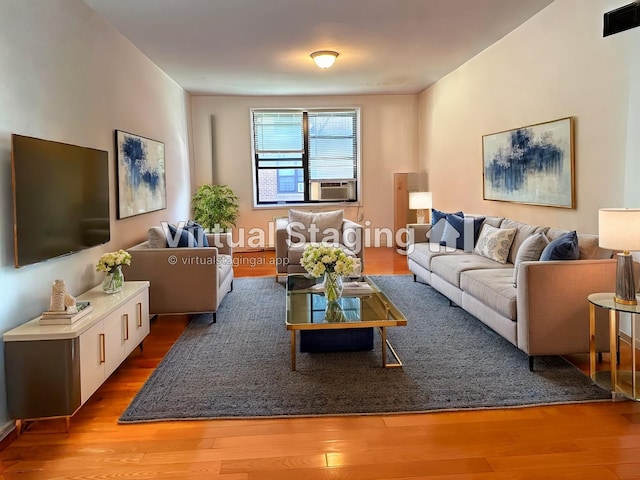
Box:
[420, 0, 640, 233]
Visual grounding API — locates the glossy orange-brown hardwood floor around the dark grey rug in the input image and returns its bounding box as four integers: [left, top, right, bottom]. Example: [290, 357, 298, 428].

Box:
[0, 249, 640, 480]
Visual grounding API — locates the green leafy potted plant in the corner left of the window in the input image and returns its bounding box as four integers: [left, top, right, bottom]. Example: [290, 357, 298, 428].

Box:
[191, 184, 239, 232]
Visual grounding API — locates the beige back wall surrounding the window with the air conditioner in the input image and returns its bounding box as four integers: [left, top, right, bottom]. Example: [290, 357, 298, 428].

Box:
[192, 95, 418, 250]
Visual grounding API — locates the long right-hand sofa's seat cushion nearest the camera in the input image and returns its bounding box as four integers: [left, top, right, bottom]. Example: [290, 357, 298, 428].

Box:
[460, 268, 518, 320]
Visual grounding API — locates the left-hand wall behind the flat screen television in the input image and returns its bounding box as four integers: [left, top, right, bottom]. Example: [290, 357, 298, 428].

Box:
[0, 0, 191, 436]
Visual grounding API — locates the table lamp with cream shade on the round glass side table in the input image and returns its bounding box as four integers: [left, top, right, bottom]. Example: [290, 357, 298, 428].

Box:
[598, 208, 640, 305]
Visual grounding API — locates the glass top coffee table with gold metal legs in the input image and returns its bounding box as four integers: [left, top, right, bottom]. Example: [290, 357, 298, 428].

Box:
[286, 274, 407, 370]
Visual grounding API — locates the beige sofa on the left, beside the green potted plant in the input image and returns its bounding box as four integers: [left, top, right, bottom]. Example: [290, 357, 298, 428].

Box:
[123, 227, 233, 322]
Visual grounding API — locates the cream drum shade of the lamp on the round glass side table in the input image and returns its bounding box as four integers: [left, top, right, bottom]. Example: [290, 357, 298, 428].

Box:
[598, 208, 640, 251]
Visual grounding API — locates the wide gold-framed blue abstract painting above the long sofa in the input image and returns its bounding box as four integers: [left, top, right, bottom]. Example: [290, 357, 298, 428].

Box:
[482, 117, 575, 208]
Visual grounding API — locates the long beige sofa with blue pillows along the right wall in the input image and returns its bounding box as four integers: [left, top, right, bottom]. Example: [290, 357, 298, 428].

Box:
[407, 209, 616, 370]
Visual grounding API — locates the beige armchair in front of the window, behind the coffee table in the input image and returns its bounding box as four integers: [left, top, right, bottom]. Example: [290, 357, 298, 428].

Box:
[275, 210, 364, 280]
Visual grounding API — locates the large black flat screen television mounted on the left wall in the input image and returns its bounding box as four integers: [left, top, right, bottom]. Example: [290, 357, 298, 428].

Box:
[11, 134, 111, 268]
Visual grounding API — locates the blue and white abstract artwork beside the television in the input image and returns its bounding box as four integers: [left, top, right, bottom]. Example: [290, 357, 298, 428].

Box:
[116, 130, 167, 218]
